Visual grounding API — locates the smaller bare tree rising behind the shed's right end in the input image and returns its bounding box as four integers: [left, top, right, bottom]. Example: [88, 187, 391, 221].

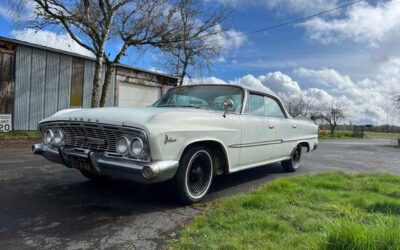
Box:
[158, 0, 230, 85]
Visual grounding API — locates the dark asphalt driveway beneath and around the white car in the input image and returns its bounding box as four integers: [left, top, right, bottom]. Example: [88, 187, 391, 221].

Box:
[0, 138, 400, 249]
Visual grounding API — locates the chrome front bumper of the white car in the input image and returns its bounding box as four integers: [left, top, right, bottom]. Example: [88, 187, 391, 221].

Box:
[32, 144, 179, 183]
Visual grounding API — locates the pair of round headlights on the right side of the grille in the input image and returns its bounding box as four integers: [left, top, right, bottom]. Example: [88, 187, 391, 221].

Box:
[117, 136, 145, 158]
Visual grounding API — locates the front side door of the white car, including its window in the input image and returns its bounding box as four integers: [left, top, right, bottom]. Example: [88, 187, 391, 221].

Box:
[239, 93, 281, 168]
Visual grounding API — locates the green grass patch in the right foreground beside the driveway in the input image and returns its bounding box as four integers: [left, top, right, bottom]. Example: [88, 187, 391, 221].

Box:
[169, 173, 400, 249]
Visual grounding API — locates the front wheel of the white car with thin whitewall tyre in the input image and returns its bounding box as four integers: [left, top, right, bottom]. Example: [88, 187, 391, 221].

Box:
[175, 146, 213, 205]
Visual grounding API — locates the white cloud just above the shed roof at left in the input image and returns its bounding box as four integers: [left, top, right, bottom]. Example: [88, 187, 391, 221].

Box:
[11, 29, 93, 56]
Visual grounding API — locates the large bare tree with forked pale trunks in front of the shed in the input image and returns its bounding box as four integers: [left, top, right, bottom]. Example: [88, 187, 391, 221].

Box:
[8, 0, 177, 107]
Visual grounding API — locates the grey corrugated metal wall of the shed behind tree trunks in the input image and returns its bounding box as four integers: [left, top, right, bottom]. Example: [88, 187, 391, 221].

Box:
[13, 45, 115, 130]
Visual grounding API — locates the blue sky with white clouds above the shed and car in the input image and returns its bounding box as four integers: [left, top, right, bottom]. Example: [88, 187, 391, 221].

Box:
[0, 0, 400, 124]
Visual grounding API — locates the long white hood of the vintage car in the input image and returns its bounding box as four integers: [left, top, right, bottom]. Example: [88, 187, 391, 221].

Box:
[40, 107, 233, 134]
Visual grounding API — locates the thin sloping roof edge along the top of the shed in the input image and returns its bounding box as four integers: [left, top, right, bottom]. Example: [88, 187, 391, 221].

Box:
[0, 36, 179, 79]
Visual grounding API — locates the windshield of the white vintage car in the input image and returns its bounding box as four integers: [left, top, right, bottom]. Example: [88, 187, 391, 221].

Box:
[152, 85, 243, 113]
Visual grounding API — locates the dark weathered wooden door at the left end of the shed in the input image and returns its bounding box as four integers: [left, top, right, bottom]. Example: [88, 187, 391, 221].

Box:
[0, 43, 15, 114]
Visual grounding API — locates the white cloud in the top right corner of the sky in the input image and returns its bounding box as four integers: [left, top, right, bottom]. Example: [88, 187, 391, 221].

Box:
[300, 0, 400, 59]
